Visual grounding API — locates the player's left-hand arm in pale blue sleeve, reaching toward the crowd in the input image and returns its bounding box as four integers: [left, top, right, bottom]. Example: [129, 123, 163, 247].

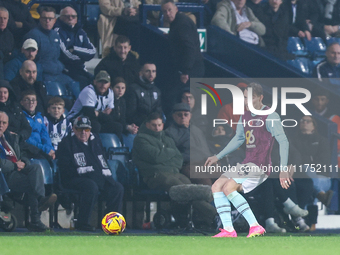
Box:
[204, 116, 245, 166]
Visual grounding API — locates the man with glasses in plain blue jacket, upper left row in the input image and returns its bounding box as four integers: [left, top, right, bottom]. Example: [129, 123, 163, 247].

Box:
[24, 7, 80, 98]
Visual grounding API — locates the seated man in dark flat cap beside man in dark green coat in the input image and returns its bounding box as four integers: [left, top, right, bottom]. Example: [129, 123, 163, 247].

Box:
[165, 103, 212, 185]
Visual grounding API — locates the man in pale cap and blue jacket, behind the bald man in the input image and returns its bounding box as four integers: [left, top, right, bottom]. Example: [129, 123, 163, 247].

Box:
[4, 38, 42, 81]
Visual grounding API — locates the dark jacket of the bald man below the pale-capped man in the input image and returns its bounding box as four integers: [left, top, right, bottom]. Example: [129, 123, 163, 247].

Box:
[10, 75, 48, 115]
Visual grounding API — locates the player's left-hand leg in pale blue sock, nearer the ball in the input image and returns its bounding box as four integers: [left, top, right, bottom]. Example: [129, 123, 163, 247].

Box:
[211, 175, 237, 237]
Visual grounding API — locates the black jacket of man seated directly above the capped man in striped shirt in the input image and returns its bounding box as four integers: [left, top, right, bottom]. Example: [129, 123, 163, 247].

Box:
[94, 48, 140, 87]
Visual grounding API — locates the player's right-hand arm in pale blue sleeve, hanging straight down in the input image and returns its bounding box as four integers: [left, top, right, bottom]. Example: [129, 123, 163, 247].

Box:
[266, 112, 291, 189]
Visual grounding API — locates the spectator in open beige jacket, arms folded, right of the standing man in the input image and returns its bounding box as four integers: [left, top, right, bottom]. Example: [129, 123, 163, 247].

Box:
[211, 0, 266, 47]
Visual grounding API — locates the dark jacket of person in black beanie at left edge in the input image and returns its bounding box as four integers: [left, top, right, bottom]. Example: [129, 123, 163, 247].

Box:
[0, 84, 32, 141]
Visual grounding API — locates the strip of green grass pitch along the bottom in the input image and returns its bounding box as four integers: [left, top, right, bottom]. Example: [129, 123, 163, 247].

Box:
[0, 233, 340, 255]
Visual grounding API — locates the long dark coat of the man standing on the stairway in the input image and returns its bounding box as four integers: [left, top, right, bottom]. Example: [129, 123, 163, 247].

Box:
[169, 12, 204, 77]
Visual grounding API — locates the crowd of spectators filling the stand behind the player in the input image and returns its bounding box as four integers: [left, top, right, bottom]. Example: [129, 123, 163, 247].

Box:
[0, 0, 340, 233]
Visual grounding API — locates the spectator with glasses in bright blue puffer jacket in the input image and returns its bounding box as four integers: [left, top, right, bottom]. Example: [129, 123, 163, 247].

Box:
[20, 90, 55, 159]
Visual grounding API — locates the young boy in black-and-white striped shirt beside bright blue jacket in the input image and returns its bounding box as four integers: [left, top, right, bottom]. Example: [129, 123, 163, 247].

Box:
[44, 97, 72, 151]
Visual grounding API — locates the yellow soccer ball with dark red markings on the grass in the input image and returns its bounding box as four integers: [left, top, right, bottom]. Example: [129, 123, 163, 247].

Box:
[102, 212, 126, 235]
